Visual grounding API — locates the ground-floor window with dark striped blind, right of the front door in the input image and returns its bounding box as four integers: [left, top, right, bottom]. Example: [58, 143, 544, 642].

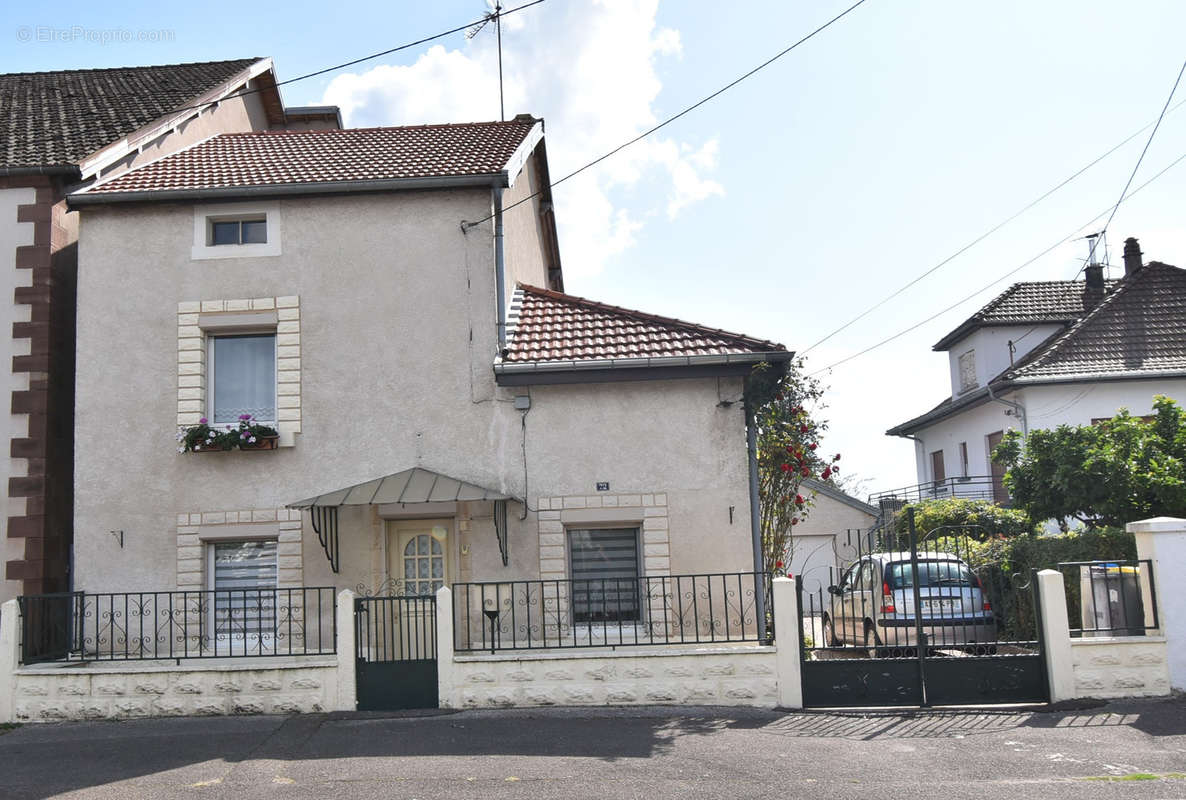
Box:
[568, 527, 642, 622]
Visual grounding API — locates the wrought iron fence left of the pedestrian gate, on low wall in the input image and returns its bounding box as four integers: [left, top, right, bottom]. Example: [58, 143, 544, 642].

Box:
[19, 587, 337, 664]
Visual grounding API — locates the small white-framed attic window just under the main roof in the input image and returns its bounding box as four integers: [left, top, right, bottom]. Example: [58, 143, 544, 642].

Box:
[190, 203, 281, 261]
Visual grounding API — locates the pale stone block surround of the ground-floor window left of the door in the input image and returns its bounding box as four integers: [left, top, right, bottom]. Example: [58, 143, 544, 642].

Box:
[177, 508, 304, 591]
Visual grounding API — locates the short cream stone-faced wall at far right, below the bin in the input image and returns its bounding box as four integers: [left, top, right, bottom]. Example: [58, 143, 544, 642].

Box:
[1071, 636, 1169, 698]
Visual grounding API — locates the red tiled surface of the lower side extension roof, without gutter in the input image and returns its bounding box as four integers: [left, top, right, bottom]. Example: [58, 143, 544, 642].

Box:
[502, 284, 790, 364]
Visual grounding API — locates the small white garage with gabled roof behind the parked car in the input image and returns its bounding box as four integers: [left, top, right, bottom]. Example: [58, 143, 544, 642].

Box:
[788, 478, 879, 594]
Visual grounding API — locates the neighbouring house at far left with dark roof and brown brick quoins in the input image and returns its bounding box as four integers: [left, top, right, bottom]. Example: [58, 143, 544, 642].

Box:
[0, 58, 340, 601]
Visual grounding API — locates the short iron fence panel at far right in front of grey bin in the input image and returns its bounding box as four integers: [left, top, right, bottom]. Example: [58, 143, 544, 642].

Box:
[1058, 558, 1161, 636]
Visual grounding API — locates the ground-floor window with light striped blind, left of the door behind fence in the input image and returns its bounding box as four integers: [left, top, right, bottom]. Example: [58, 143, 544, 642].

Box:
[206, 539, 278, 655]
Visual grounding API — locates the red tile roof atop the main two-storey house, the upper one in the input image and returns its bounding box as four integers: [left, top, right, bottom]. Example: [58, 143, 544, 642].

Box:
[85, 116, 538, 194]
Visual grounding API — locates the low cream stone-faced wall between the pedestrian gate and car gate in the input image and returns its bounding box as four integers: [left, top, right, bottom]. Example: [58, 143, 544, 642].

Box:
[440, 646, 778, 709]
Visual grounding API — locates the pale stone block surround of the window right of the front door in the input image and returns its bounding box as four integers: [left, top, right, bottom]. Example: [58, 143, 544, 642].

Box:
[537, 493, 671, 581]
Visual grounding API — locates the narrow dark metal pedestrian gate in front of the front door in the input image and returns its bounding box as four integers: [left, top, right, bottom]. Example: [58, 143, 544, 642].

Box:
[355, 595, 439, 711]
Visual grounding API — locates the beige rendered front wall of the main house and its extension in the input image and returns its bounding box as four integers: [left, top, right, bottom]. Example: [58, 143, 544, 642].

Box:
[75, 184, 751, 591]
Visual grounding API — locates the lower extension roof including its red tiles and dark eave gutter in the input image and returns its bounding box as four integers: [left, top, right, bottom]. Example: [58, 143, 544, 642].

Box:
[495, 284, 793, 384]
